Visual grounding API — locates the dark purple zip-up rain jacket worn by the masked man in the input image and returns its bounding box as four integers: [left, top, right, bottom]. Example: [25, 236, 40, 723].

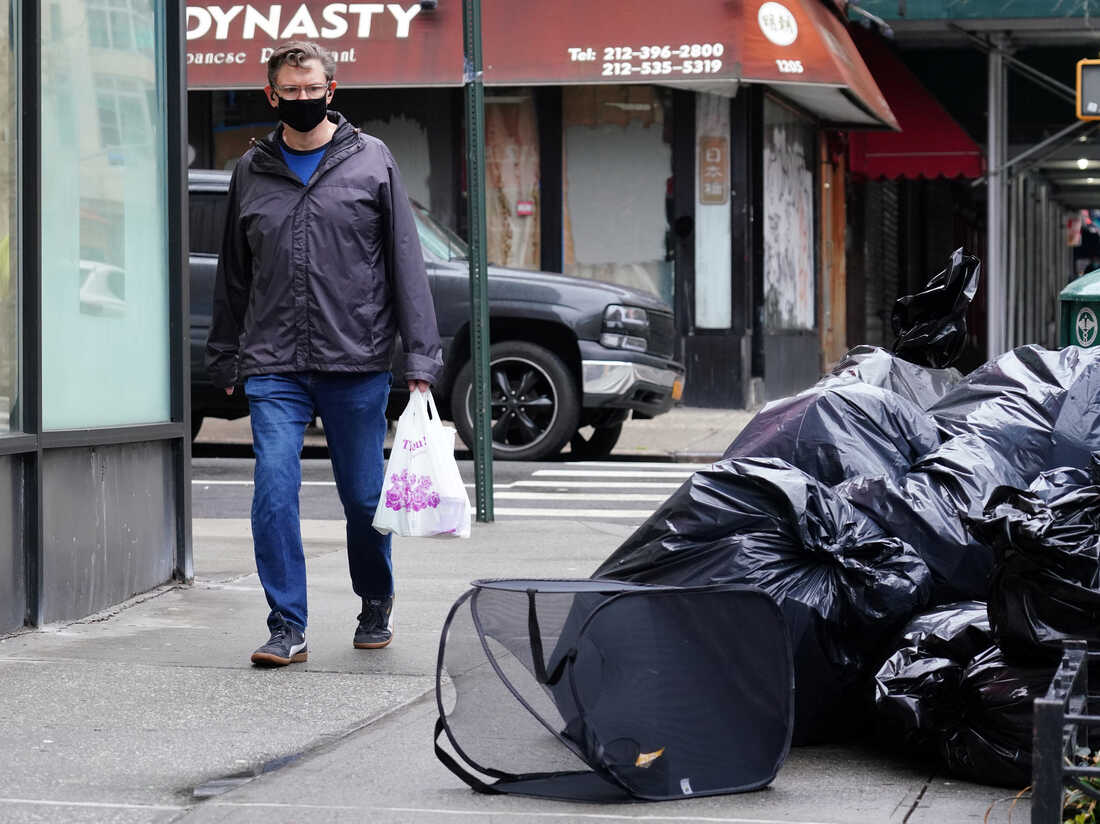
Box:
[206, 112, 443, 388]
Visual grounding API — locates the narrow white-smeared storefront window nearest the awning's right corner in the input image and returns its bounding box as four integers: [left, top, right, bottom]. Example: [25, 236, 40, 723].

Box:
[763, 99, 816, 330]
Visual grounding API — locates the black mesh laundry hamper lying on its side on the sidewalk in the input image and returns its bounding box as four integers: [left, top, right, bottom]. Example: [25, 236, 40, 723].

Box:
[436, 579, 794, 801]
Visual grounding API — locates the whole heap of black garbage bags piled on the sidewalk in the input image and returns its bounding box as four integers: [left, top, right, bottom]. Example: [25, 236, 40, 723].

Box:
[593, 250, 1100, 787]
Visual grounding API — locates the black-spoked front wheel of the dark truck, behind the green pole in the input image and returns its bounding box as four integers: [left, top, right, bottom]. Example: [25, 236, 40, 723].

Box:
[451, 341, 581, 461]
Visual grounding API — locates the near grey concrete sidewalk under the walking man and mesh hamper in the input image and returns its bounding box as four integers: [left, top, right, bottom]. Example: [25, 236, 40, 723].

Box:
[0, 519, 1027, 824]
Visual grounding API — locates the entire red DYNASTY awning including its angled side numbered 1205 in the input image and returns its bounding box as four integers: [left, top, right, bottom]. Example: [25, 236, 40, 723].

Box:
[187, 0, 894, 128]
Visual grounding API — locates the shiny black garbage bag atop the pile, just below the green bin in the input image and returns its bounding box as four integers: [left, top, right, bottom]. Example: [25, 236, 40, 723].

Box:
[928, 347, 1100, 493]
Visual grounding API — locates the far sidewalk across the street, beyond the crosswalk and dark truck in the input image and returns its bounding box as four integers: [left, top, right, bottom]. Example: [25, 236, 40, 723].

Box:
[195, 406, 756, 462]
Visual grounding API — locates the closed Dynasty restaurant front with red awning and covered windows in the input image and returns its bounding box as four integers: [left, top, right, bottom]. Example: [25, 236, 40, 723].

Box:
[187, 0, 894, 407]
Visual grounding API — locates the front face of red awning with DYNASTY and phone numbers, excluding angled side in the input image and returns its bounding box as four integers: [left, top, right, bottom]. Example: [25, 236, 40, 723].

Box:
[187, 0, 740, 89]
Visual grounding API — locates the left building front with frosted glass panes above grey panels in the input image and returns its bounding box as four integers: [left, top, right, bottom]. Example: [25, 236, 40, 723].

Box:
[0, 0, 191, 633]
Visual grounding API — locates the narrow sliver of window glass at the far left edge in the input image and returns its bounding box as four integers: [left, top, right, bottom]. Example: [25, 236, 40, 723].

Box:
[0, 3, 22, 433]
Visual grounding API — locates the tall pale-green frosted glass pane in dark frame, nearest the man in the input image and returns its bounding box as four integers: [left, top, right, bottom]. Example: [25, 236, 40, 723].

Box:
[42, 0, 171, 429]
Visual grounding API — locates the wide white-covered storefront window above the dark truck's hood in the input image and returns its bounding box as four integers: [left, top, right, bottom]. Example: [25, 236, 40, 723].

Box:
[562, 86, 673, 303]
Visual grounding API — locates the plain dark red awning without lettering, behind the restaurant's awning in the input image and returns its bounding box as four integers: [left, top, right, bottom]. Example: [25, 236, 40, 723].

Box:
[848, 26, 985, 179]
